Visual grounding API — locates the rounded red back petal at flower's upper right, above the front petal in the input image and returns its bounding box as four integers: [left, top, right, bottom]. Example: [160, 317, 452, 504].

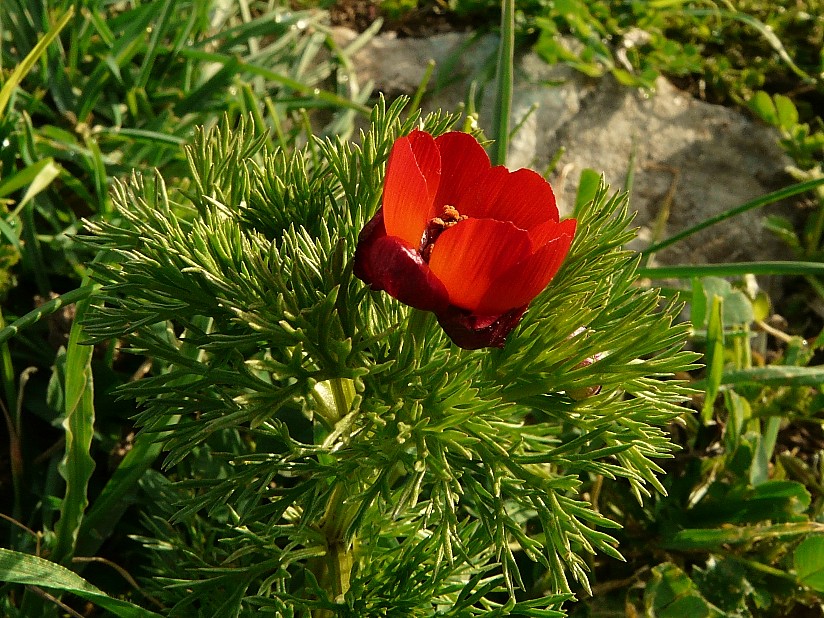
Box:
[458, 167, 558, 230]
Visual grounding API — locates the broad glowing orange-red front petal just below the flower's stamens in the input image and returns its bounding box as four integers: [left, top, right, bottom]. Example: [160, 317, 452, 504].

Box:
[429, 219, 532, 316]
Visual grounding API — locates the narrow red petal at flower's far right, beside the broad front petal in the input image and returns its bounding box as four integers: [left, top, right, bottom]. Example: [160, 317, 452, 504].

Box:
[479, 219, 576, 307]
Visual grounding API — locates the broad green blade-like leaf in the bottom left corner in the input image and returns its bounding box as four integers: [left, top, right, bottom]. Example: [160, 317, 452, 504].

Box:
[0, 548, 161, 618]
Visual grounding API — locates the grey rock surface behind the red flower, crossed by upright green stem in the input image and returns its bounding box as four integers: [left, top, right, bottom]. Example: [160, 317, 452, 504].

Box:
[336, 30, 790, 264]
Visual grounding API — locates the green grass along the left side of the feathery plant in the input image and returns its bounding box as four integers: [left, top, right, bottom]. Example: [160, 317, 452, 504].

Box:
[0, 0, 369, 616]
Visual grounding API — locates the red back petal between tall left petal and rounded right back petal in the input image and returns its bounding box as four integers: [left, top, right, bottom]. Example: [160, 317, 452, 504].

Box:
[435, 131, 491, 212]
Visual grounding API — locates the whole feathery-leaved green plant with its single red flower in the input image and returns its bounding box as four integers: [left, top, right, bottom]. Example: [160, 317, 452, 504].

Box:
[85, 102, 694, 617]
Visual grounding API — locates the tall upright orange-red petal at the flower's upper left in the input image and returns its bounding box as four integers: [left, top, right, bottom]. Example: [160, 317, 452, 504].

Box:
[383, 131, 439, 247]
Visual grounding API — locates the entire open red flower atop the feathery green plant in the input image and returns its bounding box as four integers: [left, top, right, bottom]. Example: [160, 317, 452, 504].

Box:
[354, 131, 576, 350]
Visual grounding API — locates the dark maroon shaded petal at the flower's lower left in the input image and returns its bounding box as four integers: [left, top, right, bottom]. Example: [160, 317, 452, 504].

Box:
[354, 211, 449, 312]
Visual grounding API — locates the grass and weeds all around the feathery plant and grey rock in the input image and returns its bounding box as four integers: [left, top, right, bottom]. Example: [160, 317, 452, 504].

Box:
[0, 0, 824, 617]
